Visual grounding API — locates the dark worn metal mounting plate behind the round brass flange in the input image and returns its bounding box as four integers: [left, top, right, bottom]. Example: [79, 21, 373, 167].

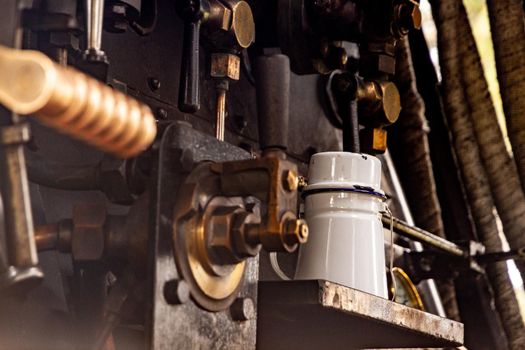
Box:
[146, 122, 259, 350]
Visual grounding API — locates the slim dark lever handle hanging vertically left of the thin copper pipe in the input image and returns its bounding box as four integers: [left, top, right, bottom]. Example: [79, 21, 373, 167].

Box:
[179, 19, 201, 113]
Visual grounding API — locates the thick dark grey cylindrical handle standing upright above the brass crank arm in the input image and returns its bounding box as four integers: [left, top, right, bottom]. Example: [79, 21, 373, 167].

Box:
[256, 54, 290, 150]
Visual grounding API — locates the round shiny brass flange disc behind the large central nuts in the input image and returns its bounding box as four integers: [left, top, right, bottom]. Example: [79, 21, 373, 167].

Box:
[173, 163, 246, 311]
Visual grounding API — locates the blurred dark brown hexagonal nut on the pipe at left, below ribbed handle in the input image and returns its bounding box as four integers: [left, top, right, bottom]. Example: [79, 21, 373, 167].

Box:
[71, 204, 107, 262]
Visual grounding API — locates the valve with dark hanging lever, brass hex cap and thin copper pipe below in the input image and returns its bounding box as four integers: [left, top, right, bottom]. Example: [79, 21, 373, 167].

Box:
[177, 0, 255, 141]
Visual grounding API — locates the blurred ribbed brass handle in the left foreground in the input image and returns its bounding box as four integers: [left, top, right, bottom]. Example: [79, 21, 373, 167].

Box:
[0, 46, 157, 158]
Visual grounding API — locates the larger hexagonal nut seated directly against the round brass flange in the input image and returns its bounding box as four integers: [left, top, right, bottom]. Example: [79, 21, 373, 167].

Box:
[206, 207, 243, 265]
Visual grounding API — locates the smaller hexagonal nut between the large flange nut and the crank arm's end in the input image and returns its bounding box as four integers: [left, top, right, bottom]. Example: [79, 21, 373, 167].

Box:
[232, 211, 261, 258]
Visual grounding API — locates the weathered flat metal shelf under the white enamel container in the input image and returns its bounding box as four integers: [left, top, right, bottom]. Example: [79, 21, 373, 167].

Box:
[257, 280, 463, 350]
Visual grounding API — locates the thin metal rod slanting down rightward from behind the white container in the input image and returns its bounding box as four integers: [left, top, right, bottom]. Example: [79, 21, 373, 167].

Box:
[381, 215, 466, 256]
